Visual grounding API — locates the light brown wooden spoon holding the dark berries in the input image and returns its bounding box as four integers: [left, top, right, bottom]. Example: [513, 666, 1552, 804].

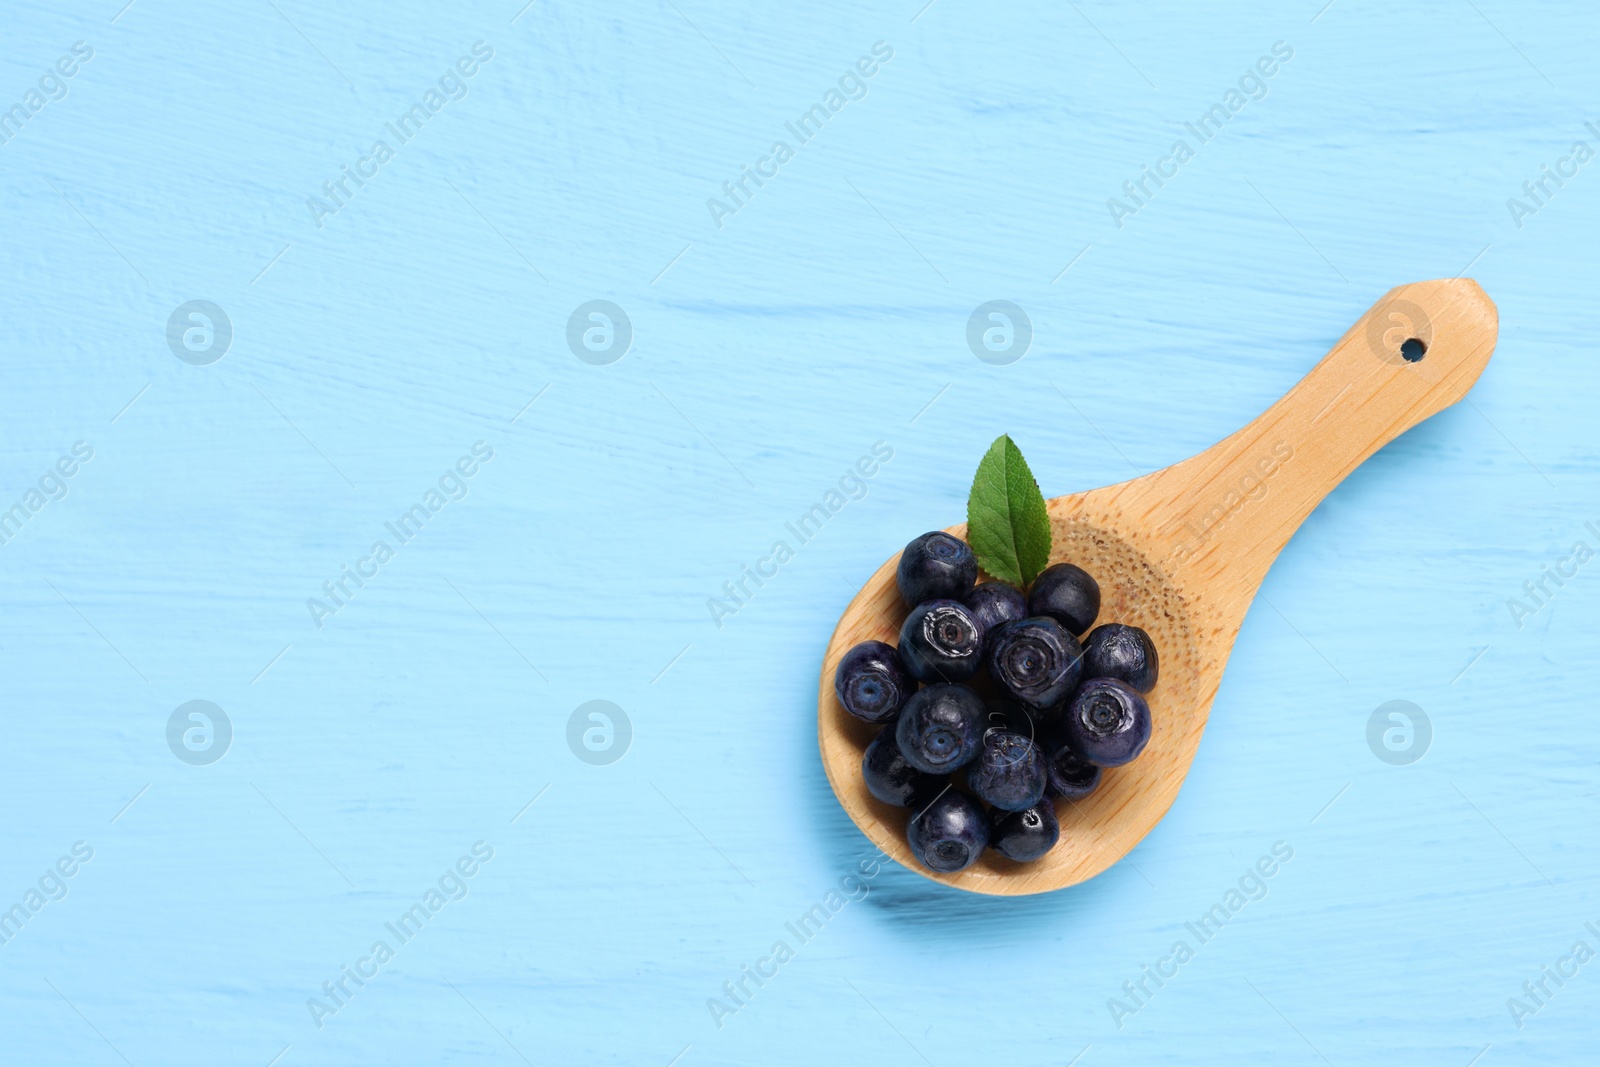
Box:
[818, 278, 1499, 896]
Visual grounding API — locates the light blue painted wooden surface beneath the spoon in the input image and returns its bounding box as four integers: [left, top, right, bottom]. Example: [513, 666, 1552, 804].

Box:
[0, 0, 1600, 1067]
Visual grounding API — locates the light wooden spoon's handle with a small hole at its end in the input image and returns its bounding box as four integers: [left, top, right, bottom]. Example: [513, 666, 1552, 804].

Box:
[1120, 278, 1499, 619]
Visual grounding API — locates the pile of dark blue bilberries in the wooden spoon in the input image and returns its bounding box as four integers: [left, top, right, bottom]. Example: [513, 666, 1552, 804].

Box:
[834, 531, 1158, 873]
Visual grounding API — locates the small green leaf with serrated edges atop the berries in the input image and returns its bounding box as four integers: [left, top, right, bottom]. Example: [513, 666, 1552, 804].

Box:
[966, 434, 1050, 589]
